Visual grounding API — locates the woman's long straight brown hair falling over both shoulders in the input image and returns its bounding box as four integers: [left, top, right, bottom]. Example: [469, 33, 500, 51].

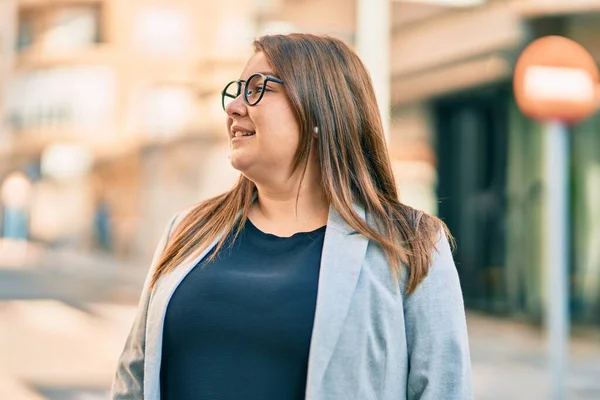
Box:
[151, 33, 449, 293]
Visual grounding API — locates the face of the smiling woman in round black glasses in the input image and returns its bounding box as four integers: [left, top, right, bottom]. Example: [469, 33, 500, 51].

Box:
[226, 52, 300, 180]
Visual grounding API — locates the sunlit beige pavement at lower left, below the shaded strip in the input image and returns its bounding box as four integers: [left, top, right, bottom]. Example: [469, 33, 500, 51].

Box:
[0, 300, 135, 400]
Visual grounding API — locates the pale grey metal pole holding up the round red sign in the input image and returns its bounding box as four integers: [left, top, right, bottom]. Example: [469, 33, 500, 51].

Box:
[544, 121, 569, 400]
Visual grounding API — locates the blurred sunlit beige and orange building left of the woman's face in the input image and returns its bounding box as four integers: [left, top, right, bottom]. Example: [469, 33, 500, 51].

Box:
[0, 0, 254, 255]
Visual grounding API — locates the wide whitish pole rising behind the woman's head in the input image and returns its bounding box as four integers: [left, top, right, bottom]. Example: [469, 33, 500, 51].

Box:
[356, 0, 391, 141]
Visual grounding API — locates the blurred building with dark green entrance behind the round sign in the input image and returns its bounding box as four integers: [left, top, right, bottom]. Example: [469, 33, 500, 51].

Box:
[380, 0, 600, 322]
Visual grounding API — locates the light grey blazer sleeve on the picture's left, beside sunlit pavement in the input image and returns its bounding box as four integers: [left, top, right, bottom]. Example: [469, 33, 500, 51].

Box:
[110, 215, 179, 400]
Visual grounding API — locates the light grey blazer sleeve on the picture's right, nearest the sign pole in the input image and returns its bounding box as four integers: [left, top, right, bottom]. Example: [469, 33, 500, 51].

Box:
[404, 232, 473, 400]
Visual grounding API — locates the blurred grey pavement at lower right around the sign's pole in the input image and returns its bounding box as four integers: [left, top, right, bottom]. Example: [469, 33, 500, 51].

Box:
[467, 312, 600, 400]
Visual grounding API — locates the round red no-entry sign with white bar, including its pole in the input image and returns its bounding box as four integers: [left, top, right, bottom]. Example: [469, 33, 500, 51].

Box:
[513, 36, 599, 400]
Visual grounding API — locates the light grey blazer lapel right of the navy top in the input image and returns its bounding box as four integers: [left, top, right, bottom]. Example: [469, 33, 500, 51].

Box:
[306, 205, 369, 399]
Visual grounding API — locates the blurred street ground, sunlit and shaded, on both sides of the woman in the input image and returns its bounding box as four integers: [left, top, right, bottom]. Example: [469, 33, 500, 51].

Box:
[0, 245, 600, 400]
